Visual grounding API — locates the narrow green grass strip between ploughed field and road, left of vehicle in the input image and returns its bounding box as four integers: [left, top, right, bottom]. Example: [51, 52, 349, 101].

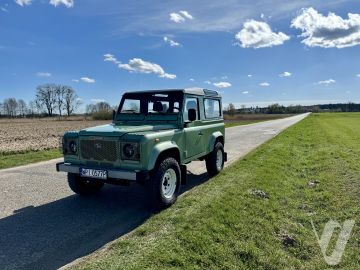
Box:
[0, 148, 62, 169]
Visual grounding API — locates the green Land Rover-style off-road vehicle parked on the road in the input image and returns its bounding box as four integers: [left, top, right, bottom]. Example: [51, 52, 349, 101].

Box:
[56, 88, 227, 207]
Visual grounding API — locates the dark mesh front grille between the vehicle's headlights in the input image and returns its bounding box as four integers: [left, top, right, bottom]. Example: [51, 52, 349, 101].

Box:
[80, 139, 118, 162]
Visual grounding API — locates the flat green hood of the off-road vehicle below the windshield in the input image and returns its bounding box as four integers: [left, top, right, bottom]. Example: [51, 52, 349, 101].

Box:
[79, 124, 176, 137]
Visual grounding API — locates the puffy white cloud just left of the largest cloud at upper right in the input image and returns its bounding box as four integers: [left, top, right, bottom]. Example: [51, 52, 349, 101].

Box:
[235, 20, 290, 49]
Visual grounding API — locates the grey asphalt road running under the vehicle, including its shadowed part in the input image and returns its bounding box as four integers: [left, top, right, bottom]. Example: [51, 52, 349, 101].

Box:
[0, 114, 307, 269]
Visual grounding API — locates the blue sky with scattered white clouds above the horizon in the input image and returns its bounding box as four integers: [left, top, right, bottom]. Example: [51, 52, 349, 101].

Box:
[0, 0, 360, 106]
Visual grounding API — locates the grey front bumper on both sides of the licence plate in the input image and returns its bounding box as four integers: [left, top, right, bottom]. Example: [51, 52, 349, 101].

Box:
[56, 162, 149, 182]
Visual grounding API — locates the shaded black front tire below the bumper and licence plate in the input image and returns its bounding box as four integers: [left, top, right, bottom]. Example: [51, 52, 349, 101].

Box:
[68, 173, 104, 196]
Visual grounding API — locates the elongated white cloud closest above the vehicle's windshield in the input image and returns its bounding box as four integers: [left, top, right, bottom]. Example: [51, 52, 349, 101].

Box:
[118, 58, 176, 79]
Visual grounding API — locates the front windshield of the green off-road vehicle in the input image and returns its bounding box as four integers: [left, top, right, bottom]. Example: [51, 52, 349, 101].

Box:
[117, 91, 183, 120]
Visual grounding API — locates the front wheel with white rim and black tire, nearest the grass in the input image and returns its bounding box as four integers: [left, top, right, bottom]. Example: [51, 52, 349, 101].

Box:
[148, 157, 181, 210]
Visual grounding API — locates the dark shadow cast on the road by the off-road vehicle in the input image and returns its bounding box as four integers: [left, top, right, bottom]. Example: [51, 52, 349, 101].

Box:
[0, 173, 208, 269]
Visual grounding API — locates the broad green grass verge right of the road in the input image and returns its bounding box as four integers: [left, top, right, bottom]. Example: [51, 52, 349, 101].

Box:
[75, 113, 360, 269]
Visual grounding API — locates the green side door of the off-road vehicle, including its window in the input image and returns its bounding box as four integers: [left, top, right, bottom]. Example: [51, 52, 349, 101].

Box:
[184, 96, 205, 158]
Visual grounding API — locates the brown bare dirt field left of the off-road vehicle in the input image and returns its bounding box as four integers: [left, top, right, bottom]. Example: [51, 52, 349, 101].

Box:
[0, 118, 110, 153]
